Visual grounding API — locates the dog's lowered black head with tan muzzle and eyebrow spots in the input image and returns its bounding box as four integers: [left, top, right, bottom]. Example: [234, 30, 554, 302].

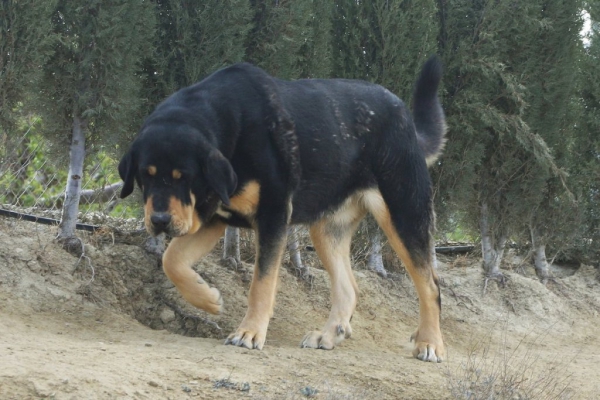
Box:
[119, 123, 237, 237]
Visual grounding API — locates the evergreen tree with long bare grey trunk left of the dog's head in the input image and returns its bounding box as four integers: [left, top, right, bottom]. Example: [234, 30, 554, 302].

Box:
[38, 0, 154, 242]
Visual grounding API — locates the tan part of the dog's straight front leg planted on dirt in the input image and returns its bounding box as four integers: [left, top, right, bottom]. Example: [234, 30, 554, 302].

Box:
[225, 235, 285, 350]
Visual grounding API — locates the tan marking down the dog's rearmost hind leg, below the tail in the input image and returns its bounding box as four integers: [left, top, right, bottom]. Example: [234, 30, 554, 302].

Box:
[363, 190, 445, 362]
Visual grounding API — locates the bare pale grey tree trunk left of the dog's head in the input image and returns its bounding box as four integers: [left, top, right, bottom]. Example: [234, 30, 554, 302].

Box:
[58, 113, 85, 240]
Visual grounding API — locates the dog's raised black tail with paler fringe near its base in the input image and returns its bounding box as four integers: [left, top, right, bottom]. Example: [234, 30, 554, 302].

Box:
[412, 56, 446, 165]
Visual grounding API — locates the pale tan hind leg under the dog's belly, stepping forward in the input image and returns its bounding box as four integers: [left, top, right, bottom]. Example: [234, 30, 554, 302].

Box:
[300, 196, 365, 350]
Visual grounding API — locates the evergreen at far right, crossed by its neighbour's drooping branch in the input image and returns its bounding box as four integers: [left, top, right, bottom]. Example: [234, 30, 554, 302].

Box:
[511, 0, 583, 282]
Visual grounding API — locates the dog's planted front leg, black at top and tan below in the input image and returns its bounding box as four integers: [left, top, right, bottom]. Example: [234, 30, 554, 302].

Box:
[225, 202, 287, 350]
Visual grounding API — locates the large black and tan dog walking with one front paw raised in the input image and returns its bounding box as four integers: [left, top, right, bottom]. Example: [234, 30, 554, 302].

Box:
[119, 58, 445, 362]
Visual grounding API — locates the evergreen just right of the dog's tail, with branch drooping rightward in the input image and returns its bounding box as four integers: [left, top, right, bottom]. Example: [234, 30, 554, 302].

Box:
[435, 0, 561, 278]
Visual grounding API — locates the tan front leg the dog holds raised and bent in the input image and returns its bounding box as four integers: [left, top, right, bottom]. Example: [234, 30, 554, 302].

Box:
[163, 222, 226, 314]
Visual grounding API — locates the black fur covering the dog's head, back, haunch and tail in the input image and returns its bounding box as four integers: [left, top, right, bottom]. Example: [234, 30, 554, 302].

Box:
[119, 57, 445, 265]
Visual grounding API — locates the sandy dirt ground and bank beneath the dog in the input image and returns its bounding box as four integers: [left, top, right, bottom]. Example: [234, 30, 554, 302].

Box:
[0, 219, 600, 399]
